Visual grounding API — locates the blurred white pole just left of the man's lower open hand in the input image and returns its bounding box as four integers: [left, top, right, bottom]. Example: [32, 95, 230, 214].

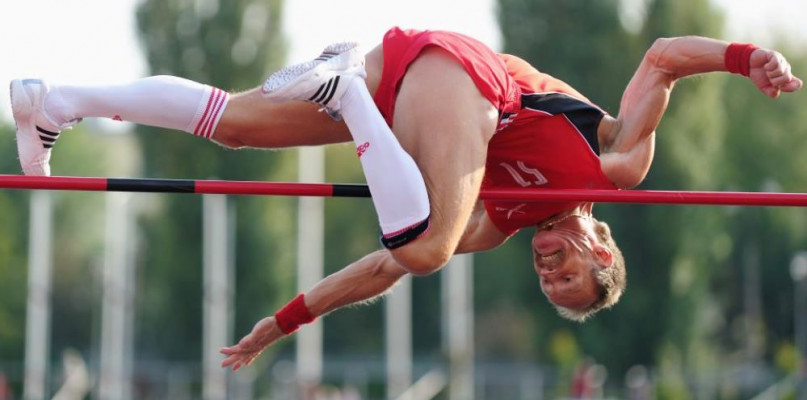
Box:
[202, 195, 231, 400]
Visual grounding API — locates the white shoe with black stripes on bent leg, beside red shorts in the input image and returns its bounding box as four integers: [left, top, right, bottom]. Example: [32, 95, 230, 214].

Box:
[261, 42, 367, 121]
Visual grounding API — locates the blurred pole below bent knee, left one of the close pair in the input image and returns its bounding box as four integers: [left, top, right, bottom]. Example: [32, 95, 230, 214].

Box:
[384, 275, 412, 400]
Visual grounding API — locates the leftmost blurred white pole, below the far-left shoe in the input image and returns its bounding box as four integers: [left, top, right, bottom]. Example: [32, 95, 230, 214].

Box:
[23, 191, 53, 400]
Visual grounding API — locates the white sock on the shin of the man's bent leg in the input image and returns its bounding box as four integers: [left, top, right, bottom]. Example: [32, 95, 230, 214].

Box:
[341, 79, 430, 236]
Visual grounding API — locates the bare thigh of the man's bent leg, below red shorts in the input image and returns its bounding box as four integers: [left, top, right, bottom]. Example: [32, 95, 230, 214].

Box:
[393, 47, 498, 268]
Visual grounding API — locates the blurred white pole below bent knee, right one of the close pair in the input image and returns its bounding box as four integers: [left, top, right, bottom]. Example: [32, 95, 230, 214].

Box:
[442, 254, 474, 400]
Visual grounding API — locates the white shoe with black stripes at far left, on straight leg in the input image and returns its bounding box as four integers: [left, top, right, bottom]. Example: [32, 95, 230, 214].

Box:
[10, 79, 79, 176]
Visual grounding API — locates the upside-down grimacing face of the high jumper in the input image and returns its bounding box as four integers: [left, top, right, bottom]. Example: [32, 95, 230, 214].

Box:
[532, 214, 612, 309]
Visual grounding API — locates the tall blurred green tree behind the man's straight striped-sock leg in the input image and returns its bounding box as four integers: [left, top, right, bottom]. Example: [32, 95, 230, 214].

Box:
[137, 0, 295, 360]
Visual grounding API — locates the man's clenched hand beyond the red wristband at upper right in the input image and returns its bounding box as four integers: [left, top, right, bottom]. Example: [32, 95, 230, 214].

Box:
[749, 48, 803, 98]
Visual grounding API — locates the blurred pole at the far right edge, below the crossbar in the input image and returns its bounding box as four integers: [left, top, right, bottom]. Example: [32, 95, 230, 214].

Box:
[790, 251, 807, 400]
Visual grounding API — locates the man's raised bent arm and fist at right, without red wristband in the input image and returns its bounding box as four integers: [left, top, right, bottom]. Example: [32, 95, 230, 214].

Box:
[602, 36, 802, 188]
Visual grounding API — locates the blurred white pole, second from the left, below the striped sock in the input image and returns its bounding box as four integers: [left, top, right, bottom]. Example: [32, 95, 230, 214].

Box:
[99, 192, 133, 400]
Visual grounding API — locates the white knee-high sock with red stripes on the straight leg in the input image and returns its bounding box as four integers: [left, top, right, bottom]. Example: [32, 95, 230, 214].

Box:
[44, 75, 229, 139]
